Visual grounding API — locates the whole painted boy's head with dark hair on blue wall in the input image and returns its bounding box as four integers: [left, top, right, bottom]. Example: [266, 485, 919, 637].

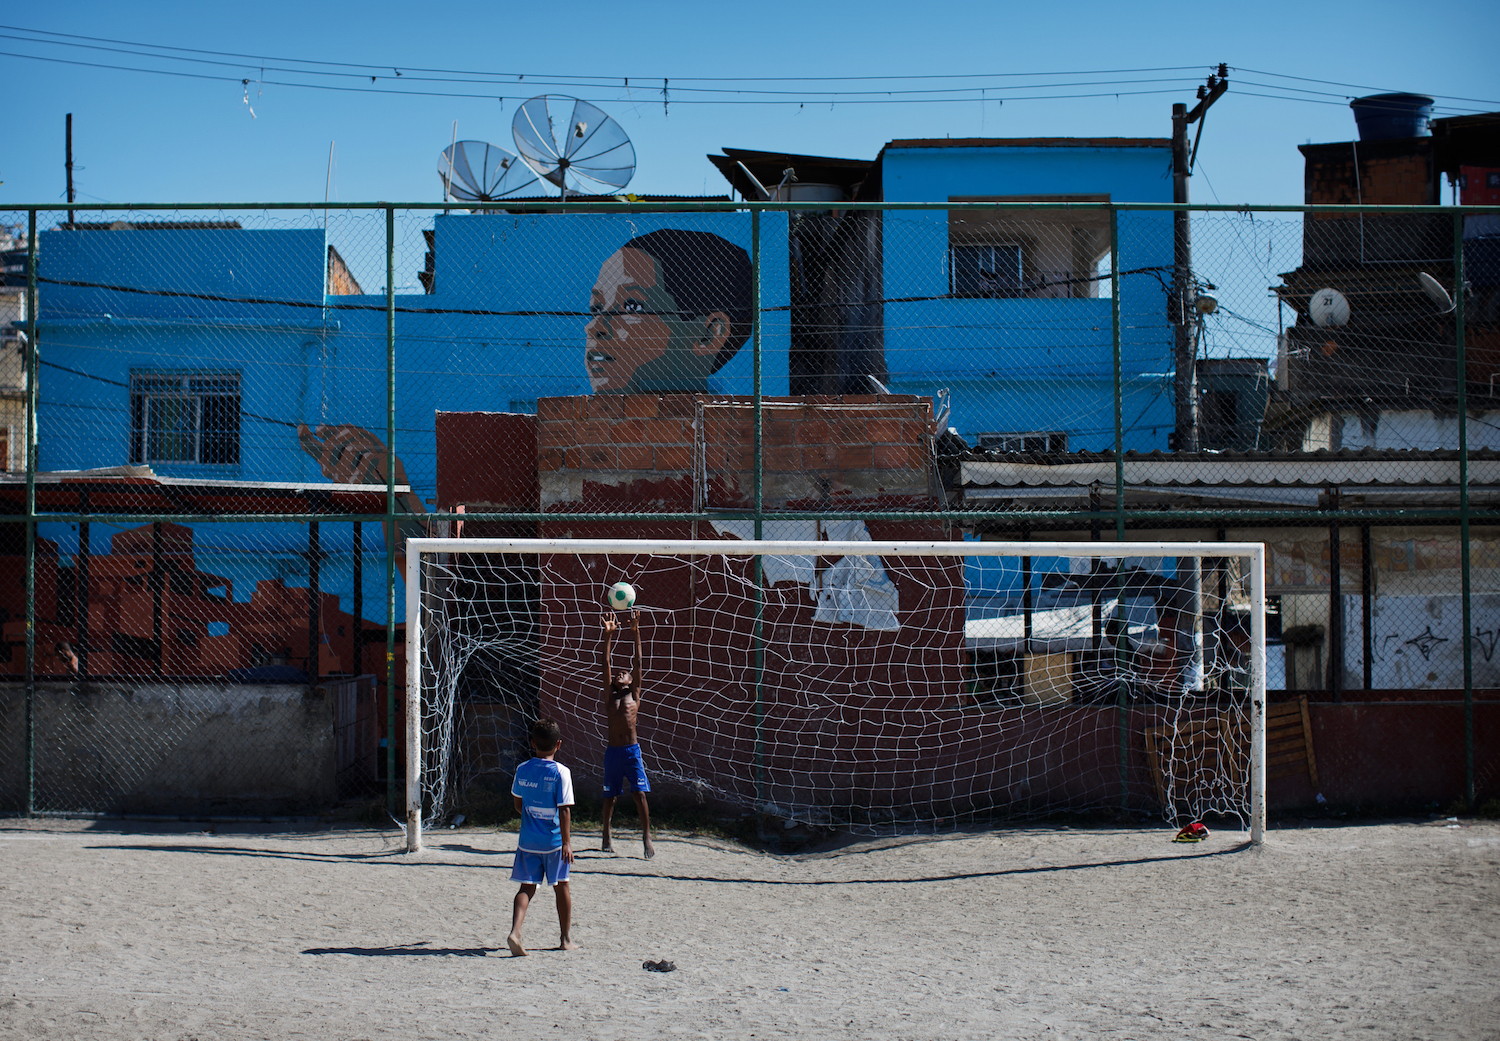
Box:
[584, 228, 750, 393]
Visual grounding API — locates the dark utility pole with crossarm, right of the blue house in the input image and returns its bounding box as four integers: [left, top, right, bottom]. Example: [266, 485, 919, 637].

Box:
[1169, 63, 1229, 452]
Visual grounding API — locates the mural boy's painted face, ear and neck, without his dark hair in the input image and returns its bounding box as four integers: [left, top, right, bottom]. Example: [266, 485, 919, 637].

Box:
[584, 246, 731, 393]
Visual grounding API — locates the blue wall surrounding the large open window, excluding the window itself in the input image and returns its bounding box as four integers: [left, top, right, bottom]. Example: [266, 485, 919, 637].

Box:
[881, 146, 1172, 450]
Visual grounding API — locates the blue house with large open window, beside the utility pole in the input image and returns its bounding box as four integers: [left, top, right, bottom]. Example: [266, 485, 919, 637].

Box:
[879, 138, 1172, 452]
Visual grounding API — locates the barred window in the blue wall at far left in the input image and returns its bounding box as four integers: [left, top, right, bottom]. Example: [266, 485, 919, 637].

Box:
[131, 372, 240, 467]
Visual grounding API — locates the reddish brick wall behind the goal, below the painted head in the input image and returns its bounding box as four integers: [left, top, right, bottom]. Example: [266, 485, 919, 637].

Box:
[522, 395, 965, 803]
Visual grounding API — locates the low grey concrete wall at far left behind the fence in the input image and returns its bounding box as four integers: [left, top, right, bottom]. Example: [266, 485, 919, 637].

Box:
[0, 683, 335, 816]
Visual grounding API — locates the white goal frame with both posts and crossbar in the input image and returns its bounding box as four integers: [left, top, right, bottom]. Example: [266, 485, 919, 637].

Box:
[405, 539, 1266, 852]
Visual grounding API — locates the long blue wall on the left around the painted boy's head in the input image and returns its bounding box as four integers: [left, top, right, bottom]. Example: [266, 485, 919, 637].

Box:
[29, 213, 789, 617]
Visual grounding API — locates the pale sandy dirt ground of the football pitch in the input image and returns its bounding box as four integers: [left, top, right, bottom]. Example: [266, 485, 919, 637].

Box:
[0, 819, 1500, 1041]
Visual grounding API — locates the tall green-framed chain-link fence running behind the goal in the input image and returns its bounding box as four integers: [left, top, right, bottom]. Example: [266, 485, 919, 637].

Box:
[0, 198, 1500, 815]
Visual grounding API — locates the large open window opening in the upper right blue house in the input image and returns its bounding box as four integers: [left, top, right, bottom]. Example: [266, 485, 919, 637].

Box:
[948, 195, 1112, 299]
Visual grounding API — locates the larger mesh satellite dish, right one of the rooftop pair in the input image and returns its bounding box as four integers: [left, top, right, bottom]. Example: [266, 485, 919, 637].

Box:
[510, 95, 636, 197]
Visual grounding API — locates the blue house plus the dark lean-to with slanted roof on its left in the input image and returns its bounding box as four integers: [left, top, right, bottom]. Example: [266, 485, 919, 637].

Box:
[708, 138, 1172, 452]
